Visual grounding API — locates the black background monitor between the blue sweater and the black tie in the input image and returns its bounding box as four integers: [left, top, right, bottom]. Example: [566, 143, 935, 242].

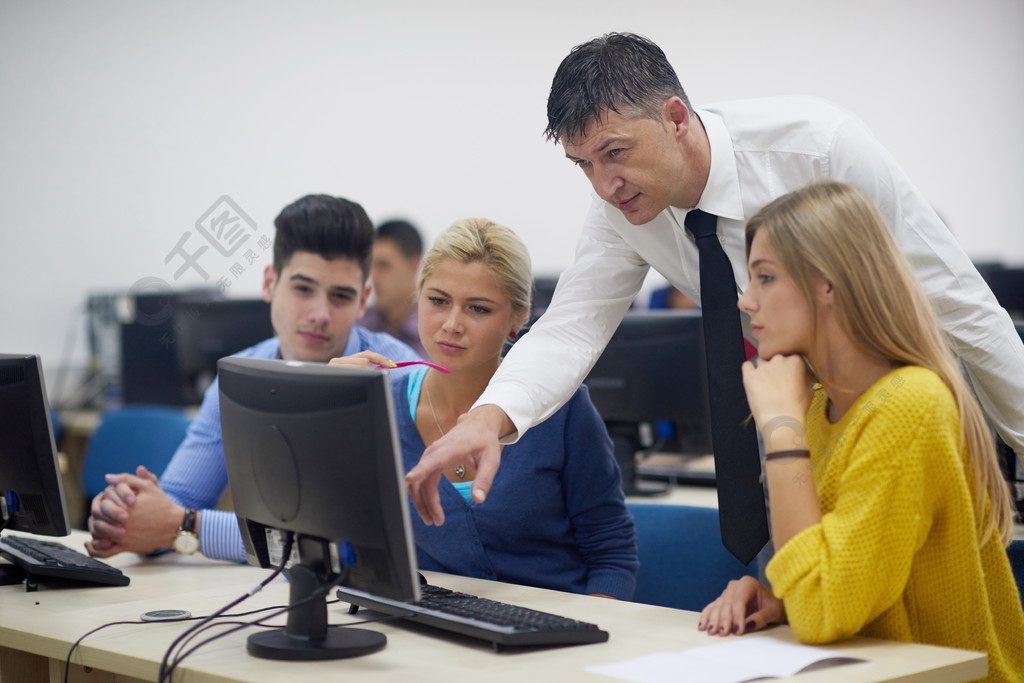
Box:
[585, 310, 712, 495]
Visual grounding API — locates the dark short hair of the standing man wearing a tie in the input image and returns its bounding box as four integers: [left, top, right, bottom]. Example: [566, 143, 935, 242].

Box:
[544, 33, 691, 143]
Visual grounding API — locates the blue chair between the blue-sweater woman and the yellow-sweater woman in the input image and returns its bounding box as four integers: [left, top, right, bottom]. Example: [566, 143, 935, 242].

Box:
[626, 503, 758, 611]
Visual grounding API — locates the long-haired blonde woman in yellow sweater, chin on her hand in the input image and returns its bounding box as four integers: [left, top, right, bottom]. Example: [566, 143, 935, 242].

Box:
[698, 182, 1024, 681]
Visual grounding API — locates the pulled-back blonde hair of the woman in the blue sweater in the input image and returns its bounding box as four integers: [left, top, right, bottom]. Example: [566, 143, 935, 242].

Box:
[420, 218, 534, 329]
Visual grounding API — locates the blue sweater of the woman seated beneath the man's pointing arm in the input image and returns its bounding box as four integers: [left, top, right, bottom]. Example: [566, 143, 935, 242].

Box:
[393, 369, 639, 600]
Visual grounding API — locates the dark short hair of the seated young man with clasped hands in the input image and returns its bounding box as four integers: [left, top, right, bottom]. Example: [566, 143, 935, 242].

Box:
[273, 195, 374, 282]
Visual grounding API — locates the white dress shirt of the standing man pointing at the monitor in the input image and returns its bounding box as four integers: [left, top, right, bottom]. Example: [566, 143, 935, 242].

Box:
[476, 97, 1024, 454]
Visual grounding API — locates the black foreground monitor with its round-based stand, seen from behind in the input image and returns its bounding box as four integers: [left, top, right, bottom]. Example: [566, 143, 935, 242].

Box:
[218, 357, 420, 659]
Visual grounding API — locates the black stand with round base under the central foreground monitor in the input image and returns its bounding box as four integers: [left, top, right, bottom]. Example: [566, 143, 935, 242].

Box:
[246, 564, 387, 661]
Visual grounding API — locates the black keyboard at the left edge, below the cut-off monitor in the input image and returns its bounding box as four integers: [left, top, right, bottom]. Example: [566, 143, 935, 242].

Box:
[0, 536, 129, 586]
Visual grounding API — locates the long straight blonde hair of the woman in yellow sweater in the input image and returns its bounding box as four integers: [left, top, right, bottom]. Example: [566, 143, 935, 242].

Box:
[746, 181, 1013, 545]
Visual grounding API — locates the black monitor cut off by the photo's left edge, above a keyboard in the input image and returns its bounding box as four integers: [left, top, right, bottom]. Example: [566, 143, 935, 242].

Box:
[0, 354, 71, 536]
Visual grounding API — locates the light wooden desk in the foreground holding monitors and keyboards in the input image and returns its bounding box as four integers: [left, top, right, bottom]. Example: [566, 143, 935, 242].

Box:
[0, 531, 987, 683]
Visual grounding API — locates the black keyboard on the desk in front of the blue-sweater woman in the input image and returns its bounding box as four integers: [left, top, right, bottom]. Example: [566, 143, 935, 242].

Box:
[338, 584, 608, 651]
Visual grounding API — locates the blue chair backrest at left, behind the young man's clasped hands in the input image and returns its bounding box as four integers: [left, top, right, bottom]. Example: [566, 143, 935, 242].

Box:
[82, 405, 189, 500]
